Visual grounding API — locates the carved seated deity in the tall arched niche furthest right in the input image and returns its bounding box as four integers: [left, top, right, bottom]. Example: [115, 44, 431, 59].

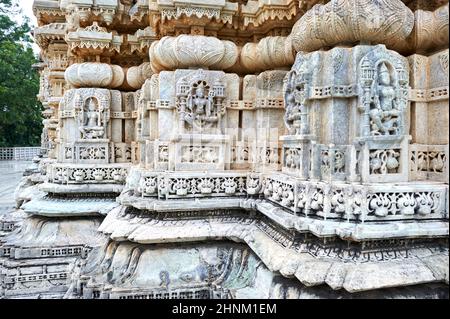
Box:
[370, 62, 401, 135]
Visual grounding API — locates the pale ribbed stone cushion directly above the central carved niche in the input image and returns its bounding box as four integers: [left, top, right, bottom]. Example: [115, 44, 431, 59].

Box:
[150, 35, 239, 72]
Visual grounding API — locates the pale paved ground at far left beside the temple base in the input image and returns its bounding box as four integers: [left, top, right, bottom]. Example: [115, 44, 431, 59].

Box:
[0, 161, 31, 215]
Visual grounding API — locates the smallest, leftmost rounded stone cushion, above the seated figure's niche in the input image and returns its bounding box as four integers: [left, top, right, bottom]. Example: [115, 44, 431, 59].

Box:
[64, 62, 125, 88]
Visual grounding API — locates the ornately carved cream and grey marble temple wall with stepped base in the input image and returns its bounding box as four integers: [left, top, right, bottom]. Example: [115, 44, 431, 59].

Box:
[0, 0, 449, 299]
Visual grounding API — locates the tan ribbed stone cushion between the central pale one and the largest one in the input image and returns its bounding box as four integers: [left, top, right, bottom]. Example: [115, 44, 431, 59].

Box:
[240, 36, 295, 72]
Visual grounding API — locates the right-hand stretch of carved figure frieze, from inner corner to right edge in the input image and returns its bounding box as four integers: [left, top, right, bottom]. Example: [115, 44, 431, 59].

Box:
[263, 179, 442, 221]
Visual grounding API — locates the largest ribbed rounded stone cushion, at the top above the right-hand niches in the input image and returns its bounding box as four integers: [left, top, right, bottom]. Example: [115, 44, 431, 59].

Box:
[291, 0, 414, 52]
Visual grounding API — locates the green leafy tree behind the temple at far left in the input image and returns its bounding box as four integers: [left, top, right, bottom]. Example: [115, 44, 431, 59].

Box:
[0, 0, 42, 147]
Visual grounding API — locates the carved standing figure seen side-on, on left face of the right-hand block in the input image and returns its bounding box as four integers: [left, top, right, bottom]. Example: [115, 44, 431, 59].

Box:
[284, 68, 309, 135]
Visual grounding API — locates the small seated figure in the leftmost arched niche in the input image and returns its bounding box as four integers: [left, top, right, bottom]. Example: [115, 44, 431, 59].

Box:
[80, 97, 105, 139]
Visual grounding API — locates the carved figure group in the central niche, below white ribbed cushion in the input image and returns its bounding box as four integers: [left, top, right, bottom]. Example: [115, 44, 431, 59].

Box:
[177, 79, 225, 132]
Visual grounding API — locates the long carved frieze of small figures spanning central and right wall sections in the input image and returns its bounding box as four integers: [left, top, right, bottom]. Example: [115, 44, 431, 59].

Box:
[135, 174, 447, 220]
